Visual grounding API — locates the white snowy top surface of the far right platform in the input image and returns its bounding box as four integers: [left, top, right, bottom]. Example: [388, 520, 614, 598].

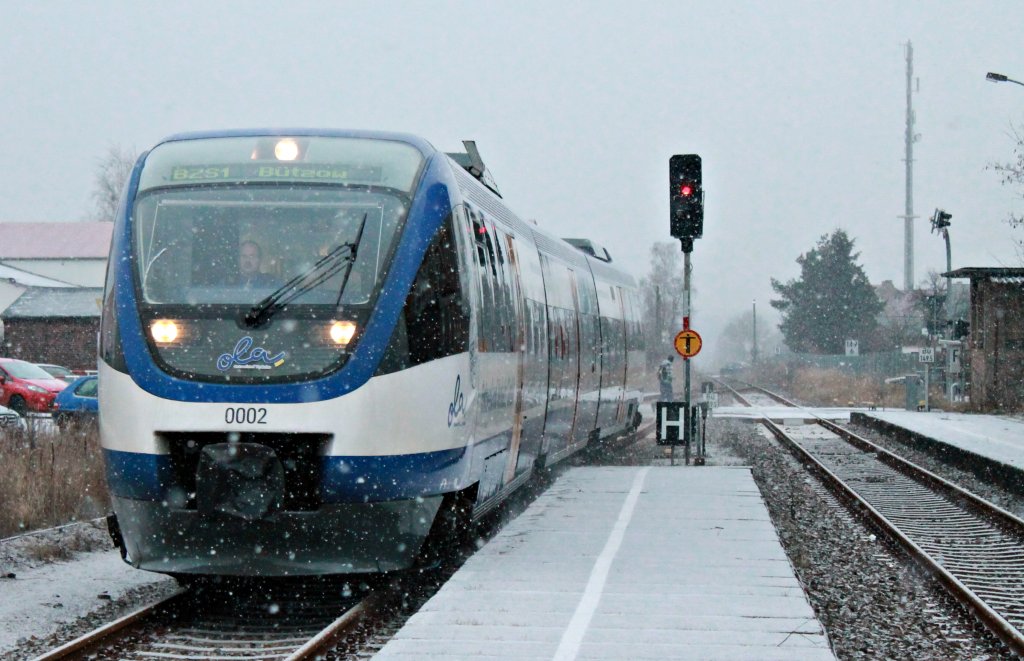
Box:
[867, 411, 1024, 470]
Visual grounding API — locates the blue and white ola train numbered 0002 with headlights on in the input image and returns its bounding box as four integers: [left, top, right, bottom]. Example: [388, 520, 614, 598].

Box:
[99, 130, 644, 576]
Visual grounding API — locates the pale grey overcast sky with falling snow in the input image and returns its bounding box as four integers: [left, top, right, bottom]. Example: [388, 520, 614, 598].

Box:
[0, 0, 1024, 362]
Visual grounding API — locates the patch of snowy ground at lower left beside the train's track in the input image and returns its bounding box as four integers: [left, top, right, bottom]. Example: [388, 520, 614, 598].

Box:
[0, 539, 174, 658]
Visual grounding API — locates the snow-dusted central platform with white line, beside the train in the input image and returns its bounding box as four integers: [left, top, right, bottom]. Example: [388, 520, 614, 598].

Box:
[374, 467, 835, 661]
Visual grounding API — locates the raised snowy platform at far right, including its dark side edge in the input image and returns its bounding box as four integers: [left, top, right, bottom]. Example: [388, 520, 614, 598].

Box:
[851, 410, 1024, 486]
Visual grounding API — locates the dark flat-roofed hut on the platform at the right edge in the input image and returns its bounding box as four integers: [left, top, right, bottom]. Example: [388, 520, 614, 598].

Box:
[943, 267, 1024, 410]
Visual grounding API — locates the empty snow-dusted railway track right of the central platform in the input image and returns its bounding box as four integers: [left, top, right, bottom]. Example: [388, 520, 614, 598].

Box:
[716, 380, 1024, 656]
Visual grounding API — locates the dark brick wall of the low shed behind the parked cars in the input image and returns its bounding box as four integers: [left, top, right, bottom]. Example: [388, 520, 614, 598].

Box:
[0, 317, 99, 369]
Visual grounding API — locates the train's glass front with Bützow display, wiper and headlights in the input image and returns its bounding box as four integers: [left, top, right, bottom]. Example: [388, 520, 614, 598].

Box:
[132, 137, 423, 383]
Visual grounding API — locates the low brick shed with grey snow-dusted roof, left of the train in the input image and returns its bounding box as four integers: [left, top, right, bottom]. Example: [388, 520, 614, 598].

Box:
[0, 287, 103, 369]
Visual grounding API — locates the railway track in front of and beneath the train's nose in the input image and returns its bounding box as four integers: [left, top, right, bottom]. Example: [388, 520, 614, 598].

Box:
[36, 586, 385, 661]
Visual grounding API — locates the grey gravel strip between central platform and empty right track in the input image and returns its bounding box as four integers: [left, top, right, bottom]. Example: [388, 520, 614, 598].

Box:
[709, 421, 1011, 660]
